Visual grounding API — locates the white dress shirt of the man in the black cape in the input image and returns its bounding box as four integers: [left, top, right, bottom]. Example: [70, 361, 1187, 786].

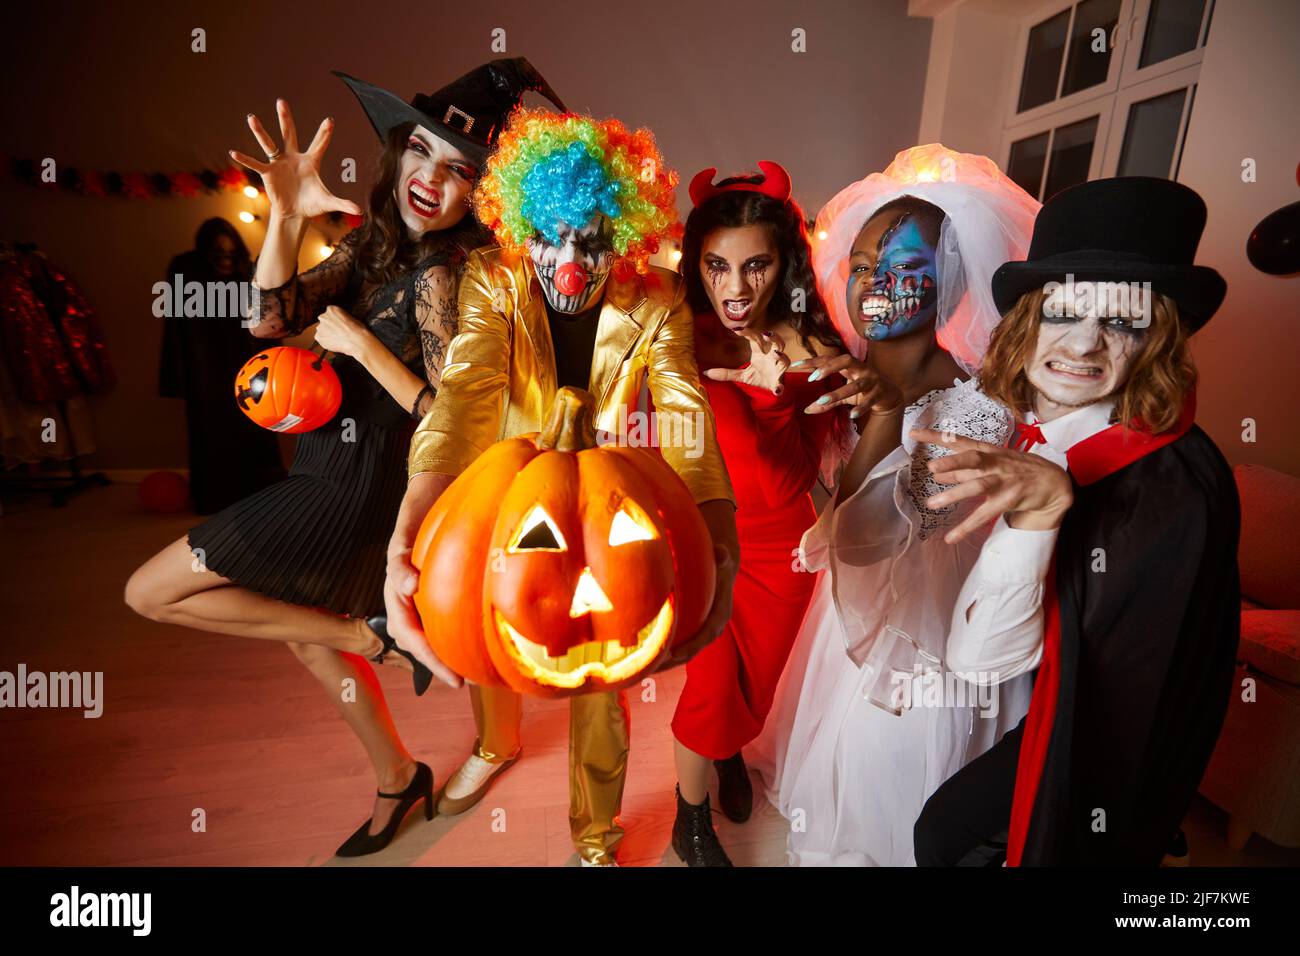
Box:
[948, 402, 1114, 684]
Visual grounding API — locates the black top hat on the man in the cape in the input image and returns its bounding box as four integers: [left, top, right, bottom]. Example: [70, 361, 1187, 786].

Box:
[993, 176, 1227, 332]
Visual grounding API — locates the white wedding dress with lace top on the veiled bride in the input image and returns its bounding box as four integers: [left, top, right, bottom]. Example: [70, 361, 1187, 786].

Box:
[745, 380, 1032, 866]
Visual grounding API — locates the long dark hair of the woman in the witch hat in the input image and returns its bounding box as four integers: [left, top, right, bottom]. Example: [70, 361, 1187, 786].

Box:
[347, 122, 490, 285]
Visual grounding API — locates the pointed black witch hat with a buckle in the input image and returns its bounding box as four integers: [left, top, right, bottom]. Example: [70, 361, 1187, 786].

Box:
[332, 56, 564, 163]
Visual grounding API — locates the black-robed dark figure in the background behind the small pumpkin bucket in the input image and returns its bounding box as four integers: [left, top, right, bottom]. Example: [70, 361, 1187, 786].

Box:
[159, 217, 285, 515]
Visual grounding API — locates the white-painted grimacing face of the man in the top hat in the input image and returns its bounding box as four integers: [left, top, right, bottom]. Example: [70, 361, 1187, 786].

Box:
[1024, 290, 1148, 421]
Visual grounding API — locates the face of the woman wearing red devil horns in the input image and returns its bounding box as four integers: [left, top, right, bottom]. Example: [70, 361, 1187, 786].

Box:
[698, 222, 781, 332]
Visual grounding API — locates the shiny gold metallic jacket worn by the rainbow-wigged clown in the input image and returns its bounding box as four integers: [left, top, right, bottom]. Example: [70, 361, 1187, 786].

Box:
[410, 246, 735, 503]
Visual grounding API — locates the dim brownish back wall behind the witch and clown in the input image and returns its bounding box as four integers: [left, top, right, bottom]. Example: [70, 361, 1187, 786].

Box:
[0, 0, 930, 468]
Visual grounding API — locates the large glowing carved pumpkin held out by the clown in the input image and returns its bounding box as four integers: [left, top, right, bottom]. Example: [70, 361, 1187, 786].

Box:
[412, 388, 715, 697]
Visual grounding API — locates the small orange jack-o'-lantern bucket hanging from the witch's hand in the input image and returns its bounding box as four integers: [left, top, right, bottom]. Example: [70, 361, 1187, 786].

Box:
[235, 346, 343, 434]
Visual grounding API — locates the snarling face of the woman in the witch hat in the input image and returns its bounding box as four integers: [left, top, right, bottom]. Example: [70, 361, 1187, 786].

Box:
[393, 126, 478, 238]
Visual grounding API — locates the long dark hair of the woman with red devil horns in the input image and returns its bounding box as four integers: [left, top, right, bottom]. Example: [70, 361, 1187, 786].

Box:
[677, 176, 844, 351]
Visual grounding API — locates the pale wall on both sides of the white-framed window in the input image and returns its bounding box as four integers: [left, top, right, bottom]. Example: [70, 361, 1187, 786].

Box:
[910, 0, 1300, 475]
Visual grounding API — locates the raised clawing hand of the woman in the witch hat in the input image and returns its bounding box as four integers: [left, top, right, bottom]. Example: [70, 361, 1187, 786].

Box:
[230, 100, 361, 219]
